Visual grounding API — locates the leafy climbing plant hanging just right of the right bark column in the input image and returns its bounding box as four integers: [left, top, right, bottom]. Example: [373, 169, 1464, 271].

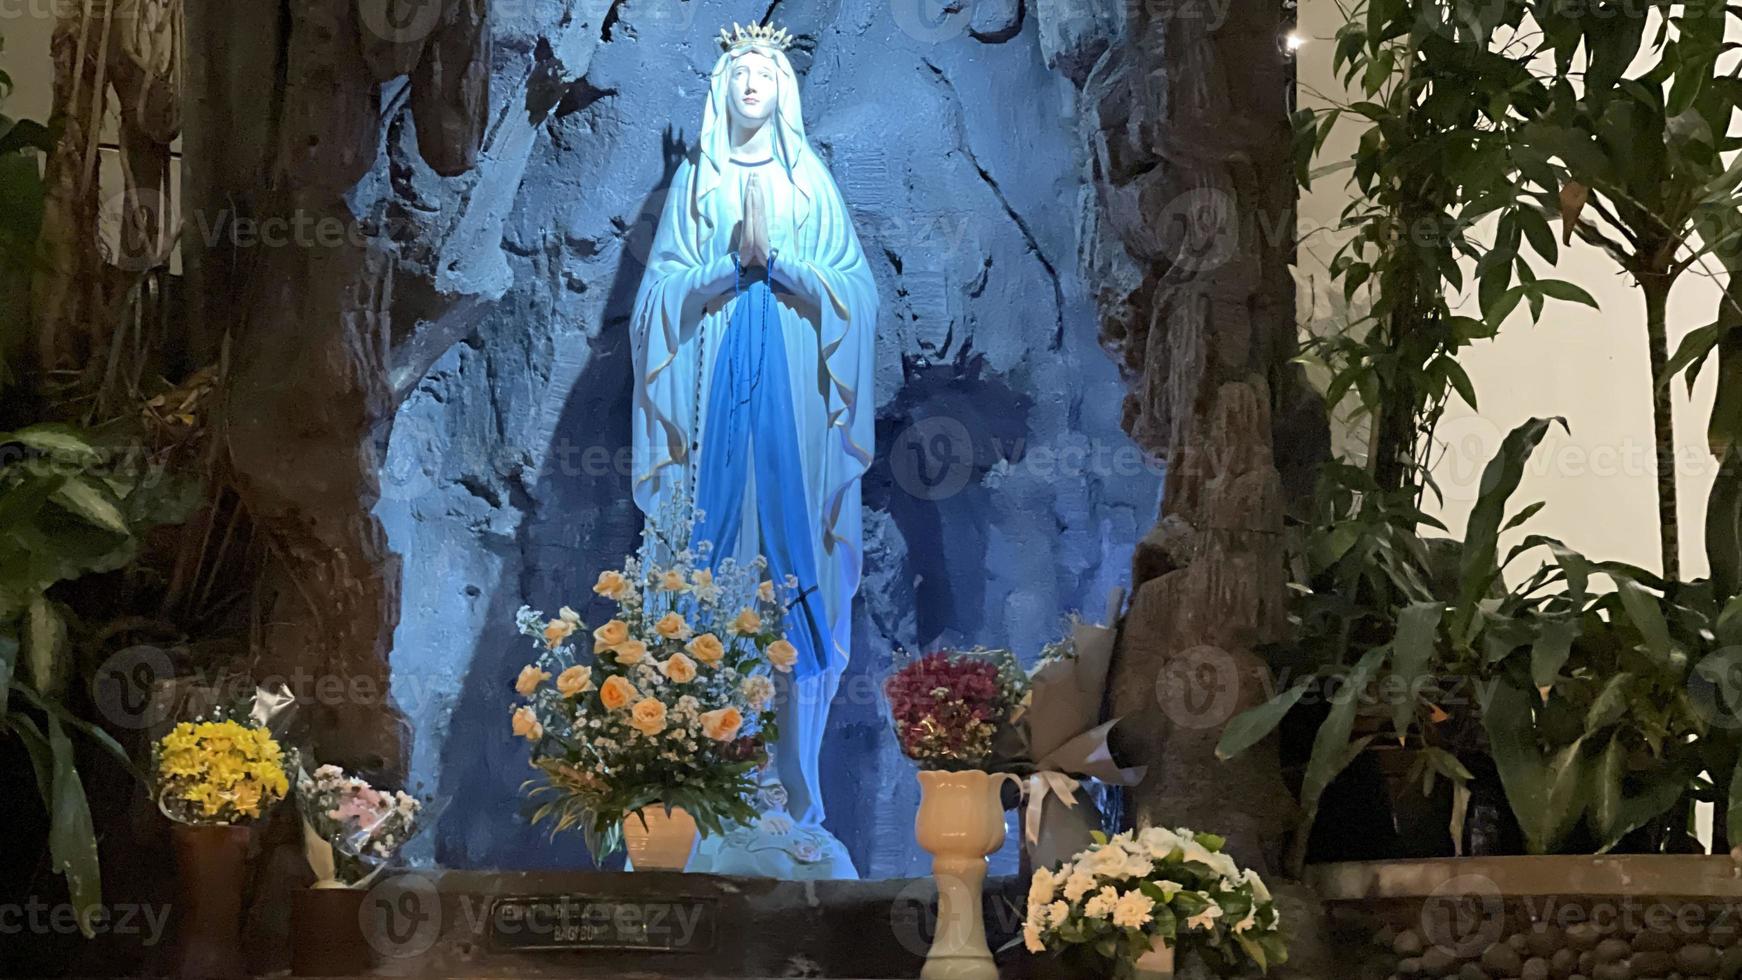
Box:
[1294, 0, 1596, 491]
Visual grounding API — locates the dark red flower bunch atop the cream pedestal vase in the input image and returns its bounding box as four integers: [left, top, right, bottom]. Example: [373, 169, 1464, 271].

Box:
[883, 651, 1026, 769]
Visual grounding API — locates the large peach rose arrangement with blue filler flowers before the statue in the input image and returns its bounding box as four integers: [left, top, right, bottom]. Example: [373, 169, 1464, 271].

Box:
[512, 518, 798, 860]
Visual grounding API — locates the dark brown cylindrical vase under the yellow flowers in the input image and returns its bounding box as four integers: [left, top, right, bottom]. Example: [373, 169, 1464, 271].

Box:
[171, 823, 249, 980]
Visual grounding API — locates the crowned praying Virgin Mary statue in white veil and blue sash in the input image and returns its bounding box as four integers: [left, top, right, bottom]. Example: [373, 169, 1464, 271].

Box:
[631, 26, 878, 877]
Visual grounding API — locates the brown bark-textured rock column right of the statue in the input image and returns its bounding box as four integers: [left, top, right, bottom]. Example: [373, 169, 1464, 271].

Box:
[1040, 0, 1322, 867]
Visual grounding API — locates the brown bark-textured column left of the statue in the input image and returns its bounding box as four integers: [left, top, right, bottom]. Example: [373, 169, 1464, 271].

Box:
[186, 0, 517, 771]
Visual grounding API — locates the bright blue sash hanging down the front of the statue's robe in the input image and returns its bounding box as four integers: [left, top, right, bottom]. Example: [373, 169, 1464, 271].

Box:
[695, 256, 829, 677]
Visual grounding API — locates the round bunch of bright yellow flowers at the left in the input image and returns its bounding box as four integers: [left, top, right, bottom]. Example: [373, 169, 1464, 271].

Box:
[152, 719, 289, 825]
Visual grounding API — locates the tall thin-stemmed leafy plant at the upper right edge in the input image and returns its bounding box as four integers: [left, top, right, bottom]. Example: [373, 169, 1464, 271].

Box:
[1514, 0, 1742, 580]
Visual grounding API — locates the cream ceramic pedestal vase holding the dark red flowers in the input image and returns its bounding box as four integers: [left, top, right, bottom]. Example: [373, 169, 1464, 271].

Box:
[913, 769, 1017, 980]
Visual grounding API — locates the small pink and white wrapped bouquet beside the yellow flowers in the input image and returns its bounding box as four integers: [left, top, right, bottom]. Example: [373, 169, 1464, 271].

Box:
[296, 766, 423, 888]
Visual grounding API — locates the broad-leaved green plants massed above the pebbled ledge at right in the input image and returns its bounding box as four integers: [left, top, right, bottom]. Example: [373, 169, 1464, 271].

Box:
[1218, 420, 1735, 869]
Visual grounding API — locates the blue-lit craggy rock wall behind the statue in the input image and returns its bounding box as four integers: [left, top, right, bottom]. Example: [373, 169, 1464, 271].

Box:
[369, 0, 1160, 876]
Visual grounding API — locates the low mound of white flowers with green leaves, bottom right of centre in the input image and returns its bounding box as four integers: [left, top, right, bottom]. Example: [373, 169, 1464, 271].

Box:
[1023, 827, 1287, 977]
